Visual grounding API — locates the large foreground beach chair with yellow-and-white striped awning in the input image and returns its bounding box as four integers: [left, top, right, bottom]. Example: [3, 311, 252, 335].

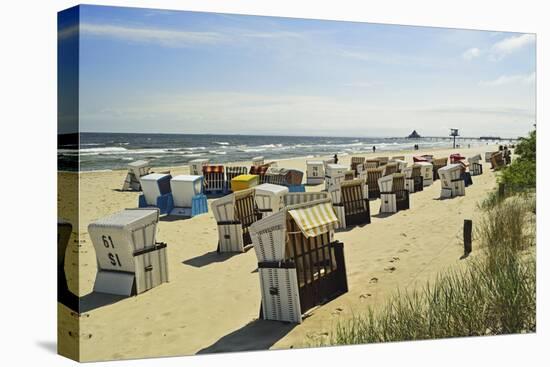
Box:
[251, 198, 348, 323]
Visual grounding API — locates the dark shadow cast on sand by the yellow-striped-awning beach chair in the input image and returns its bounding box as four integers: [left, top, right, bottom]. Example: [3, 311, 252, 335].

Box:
[197, 320, 296, 354]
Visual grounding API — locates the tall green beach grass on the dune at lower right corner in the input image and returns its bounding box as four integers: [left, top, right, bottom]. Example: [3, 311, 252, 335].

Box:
[321, 196, 536, 345]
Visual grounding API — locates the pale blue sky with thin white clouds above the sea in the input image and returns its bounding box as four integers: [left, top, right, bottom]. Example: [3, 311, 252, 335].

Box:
[59, 6, 536, 137]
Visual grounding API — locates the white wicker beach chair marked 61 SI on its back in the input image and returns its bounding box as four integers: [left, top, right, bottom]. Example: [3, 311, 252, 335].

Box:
[88, 208, 168, 296]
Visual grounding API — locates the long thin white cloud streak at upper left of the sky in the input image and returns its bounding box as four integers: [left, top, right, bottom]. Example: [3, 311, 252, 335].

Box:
[80, 23, 224, 47]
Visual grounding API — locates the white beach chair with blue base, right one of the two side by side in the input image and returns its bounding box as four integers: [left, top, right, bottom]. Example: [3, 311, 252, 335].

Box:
[169, 175, 208, 218]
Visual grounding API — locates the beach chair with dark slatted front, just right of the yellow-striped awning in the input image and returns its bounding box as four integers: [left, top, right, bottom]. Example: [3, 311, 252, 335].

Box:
[329, 178, 370, 229]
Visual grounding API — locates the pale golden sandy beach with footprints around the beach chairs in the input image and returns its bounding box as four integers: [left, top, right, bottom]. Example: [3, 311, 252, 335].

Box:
[58, 146, 502, 361]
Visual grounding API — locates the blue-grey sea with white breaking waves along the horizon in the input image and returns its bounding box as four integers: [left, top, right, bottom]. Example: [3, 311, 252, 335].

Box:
[57, 133, 496, 171]
